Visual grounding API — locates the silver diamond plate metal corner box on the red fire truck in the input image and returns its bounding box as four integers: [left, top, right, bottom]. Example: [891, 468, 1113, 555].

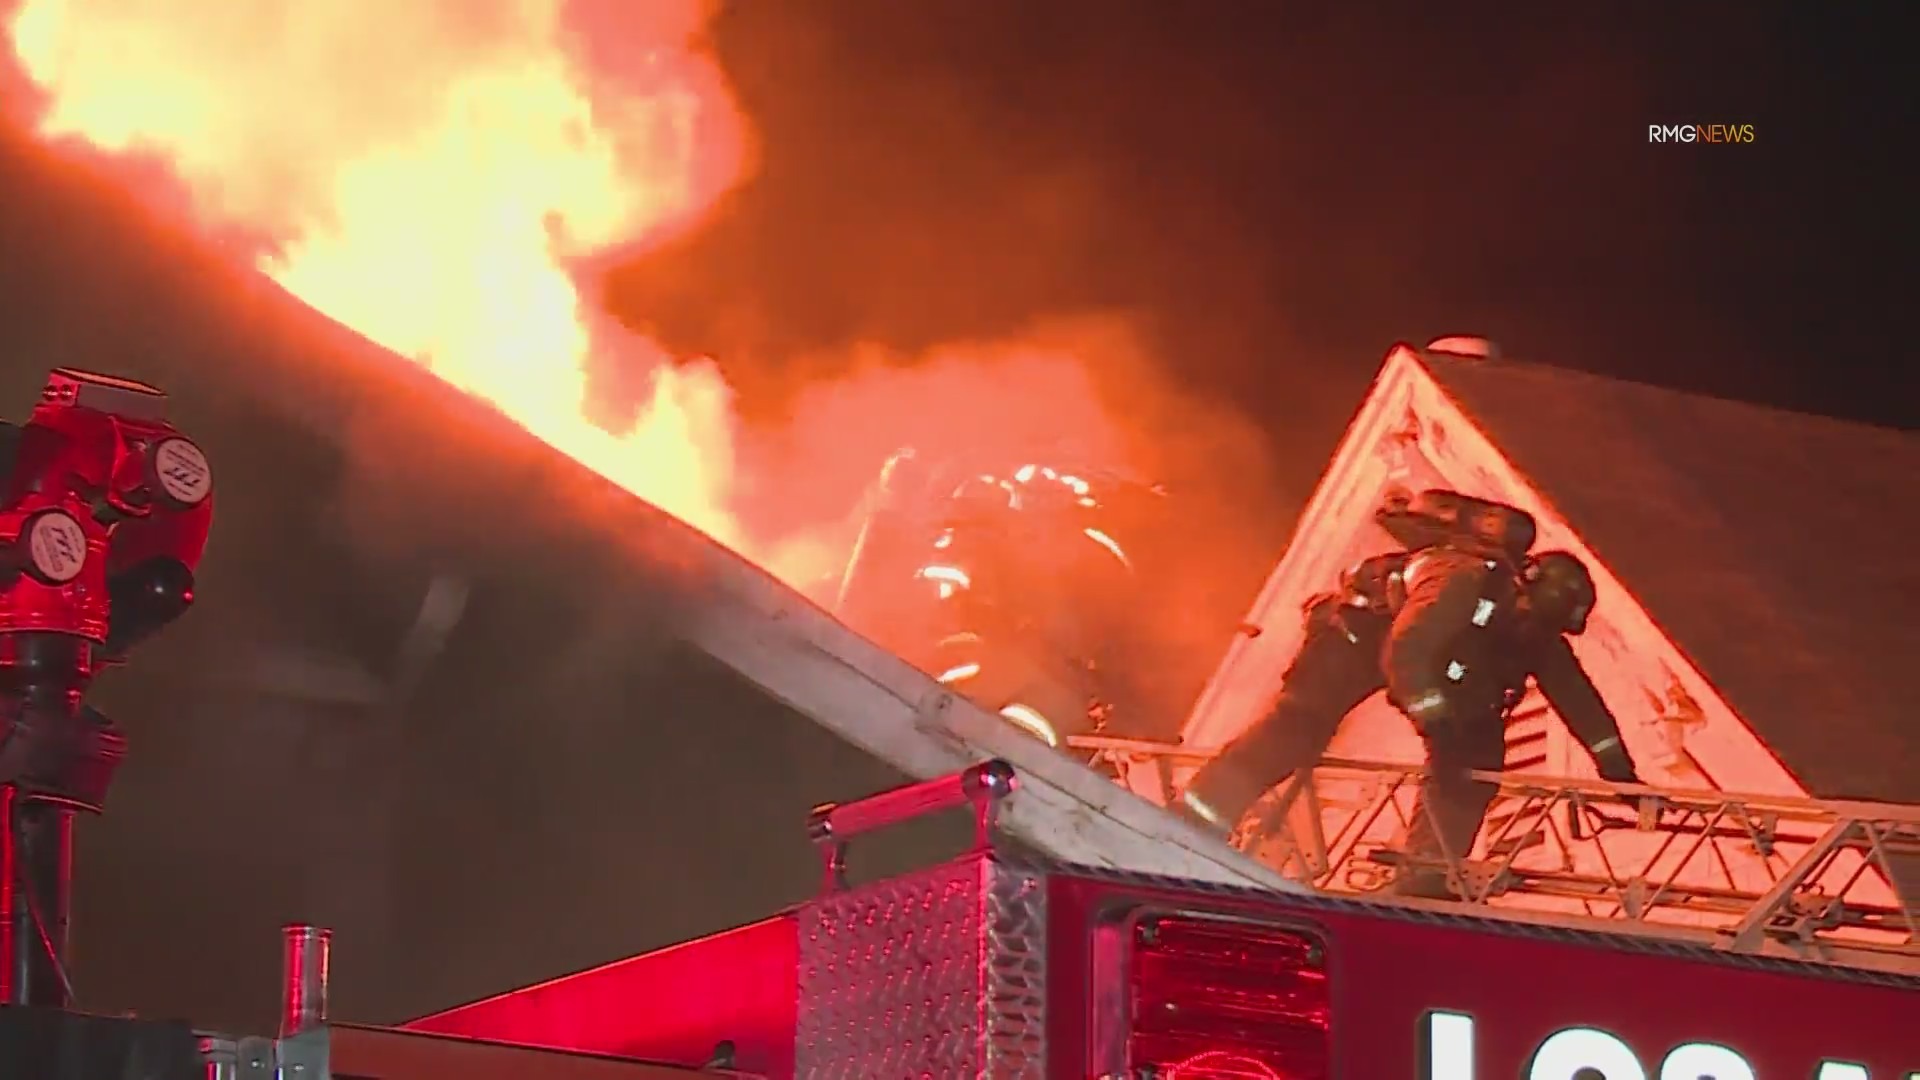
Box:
[795, 853, 1046, 1080]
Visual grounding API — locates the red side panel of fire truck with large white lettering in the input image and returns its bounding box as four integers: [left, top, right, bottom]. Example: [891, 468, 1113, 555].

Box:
[1048, 874, 1920, 1080]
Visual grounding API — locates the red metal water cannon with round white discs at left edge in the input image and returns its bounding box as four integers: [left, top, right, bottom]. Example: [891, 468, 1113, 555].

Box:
[0, 369, 213, 1007]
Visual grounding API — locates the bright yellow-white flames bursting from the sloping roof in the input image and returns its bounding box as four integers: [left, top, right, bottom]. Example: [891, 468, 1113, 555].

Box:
[8, 0, 764, 550]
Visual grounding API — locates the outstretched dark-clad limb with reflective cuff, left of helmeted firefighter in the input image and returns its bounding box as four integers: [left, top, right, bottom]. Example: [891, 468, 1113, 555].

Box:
[1175, 552, 1407, 832]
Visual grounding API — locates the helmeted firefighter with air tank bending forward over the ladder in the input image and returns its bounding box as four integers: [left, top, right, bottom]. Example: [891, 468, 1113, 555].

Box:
[1382, 544, 1638, 896]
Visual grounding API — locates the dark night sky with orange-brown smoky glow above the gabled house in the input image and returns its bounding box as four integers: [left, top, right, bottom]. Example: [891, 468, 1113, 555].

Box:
[614, 2, 1916, 434]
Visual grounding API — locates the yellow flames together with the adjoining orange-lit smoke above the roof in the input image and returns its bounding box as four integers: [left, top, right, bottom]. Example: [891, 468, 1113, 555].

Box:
[0, 0, 1269, 684]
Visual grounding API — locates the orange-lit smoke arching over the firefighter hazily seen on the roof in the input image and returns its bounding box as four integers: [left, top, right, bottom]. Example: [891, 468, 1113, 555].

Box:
[725, 317, 1284, 732]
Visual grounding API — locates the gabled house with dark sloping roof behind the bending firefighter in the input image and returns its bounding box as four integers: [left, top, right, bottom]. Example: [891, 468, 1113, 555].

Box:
[1185, 338, 1920, 911]
